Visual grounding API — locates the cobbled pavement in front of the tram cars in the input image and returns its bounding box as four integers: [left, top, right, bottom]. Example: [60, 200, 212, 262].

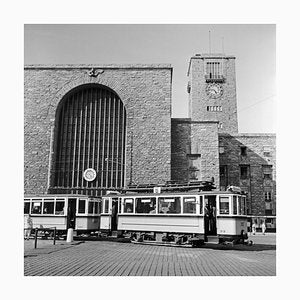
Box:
[24, 234, 276, 276]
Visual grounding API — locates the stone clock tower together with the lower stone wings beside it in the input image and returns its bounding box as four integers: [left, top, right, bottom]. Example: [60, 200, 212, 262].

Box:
[171, 54, 276, 216]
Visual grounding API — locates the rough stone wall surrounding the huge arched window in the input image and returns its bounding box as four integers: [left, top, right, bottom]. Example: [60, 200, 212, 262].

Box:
[24, 64, 172, 194]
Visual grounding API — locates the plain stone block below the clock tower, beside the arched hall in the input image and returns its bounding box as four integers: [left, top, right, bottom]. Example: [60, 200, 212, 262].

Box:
[171, 119, 219, 187]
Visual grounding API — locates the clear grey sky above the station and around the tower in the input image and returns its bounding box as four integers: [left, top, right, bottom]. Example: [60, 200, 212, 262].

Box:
[24, 24, 276, 133]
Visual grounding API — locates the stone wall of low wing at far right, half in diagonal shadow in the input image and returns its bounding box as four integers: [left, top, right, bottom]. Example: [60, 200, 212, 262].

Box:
[219, 134, 276, 216]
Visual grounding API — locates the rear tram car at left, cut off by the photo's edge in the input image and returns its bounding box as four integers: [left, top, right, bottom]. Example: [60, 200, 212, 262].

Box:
[24, 194, 101, 234]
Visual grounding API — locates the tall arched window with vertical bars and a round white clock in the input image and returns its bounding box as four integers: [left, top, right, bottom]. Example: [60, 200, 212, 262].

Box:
[51, 85, 126, 195]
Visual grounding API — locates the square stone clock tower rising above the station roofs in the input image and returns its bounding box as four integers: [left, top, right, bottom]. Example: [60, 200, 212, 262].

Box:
[187, 54, 238, 134]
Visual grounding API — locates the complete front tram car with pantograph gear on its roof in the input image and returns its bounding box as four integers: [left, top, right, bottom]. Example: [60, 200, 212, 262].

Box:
[100, 191, 248, 246]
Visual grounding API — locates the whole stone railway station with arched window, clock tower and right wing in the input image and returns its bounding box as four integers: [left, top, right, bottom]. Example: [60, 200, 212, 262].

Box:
[24, 54, 276, 226]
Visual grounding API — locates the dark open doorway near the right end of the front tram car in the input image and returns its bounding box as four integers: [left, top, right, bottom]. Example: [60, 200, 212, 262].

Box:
[204, 195, 217, 236]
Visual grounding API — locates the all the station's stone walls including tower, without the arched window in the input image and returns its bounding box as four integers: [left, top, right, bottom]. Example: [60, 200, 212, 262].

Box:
[24, 54, 276, 220]
